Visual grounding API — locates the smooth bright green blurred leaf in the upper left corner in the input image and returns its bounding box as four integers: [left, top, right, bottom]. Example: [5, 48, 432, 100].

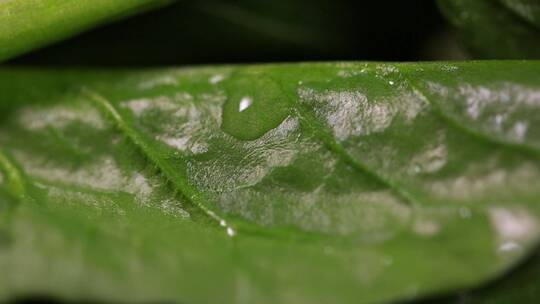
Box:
[0, 0, 170, 61]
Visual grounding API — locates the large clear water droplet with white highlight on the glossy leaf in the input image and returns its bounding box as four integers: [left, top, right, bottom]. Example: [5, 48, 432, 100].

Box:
[221, 71, 292, 140]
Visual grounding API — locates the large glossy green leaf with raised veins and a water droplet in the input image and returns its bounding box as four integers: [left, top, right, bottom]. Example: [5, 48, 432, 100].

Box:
[0, 61, 540, 303]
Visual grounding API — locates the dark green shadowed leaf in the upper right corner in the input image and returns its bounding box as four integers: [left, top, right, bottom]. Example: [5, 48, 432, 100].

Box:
[438, 0, 540, 59]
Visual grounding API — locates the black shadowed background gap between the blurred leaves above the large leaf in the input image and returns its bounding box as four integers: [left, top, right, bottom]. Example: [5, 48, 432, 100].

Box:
[10, 0, 464, 66]
